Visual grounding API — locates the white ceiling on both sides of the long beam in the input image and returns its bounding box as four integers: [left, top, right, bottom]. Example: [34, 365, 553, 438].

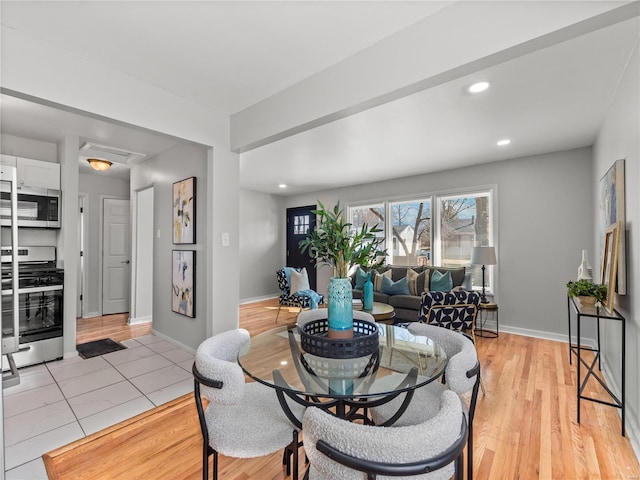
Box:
[0, 1, 639, 194]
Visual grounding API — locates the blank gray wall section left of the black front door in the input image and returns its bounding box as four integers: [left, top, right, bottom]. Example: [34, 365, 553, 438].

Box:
[240, 190, 286, 302]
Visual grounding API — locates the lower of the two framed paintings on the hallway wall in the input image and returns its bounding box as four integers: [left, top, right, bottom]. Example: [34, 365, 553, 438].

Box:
[171, 250, 196, 318]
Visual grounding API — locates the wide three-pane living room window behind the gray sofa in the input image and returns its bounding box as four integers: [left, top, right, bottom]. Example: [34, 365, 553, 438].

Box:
[348, 189, 493, 291]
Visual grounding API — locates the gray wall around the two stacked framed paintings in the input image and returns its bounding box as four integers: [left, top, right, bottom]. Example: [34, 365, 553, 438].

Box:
[131, 144, 208, 349]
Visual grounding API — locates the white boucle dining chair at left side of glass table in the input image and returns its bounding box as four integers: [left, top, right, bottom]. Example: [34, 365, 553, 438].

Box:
[193, 329, 304, 480]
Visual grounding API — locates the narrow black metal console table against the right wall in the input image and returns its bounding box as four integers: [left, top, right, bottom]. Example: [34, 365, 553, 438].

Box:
[567, 298, 626, 436]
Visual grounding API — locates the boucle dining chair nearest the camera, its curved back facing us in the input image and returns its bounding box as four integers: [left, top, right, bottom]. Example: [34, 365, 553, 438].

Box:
[302, 390, 467, 480]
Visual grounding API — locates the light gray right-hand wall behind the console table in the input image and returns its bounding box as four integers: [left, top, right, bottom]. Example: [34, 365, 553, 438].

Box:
[592, 40, 640, 455]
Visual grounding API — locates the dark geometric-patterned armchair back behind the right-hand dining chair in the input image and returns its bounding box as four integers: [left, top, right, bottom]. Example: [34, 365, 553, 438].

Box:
[418, 290, 480, 336]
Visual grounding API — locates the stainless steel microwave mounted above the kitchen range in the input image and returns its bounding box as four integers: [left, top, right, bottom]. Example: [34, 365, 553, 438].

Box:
[0, 182, 62, 228]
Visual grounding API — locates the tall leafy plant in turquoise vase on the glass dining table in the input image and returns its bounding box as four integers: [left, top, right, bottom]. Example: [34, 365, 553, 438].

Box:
[300, 201, 386, 337]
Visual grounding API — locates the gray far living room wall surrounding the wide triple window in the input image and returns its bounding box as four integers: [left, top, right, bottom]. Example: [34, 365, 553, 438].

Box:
[281, 148, 594, 341]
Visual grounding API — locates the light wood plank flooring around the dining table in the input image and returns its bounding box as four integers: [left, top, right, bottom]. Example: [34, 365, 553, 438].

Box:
[50, 301, 640, 480]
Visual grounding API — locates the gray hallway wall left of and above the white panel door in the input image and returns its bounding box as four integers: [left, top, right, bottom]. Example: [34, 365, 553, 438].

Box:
[78, 173, 129, 318]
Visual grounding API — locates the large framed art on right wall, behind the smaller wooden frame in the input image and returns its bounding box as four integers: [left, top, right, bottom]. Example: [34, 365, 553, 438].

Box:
[598, 160, 627, 295]
